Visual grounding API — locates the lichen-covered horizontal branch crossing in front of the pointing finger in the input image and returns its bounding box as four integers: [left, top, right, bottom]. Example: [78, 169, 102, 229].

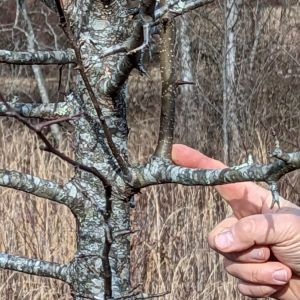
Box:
[132, 151, 300, 208]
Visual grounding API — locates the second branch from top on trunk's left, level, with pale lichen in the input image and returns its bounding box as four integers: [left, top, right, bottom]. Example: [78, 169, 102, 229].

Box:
[0, 101, 80, 120]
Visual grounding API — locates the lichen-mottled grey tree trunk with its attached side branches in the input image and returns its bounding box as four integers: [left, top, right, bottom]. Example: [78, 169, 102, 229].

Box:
[0, 0, 300, 300]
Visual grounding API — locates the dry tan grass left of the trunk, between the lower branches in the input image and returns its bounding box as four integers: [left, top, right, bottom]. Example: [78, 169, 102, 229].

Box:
[0, 118, 75, 300]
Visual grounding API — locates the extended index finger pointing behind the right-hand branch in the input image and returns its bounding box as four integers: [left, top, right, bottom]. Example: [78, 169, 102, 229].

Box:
[172, 144, 278, 219]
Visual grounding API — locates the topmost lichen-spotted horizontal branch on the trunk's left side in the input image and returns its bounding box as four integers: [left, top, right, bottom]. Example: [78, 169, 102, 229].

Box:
[0, 49, 76, 65]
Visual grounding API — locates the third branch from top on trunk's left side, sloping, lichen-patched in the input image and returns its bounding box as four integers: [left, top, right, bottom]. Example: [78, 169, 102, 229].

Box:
[0, 169, 71, 205]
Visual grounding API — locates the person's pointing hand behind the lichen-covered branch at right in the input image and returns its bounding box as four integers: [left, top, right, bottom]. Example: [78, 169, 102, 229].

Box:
[172, 144, 300, 300]
